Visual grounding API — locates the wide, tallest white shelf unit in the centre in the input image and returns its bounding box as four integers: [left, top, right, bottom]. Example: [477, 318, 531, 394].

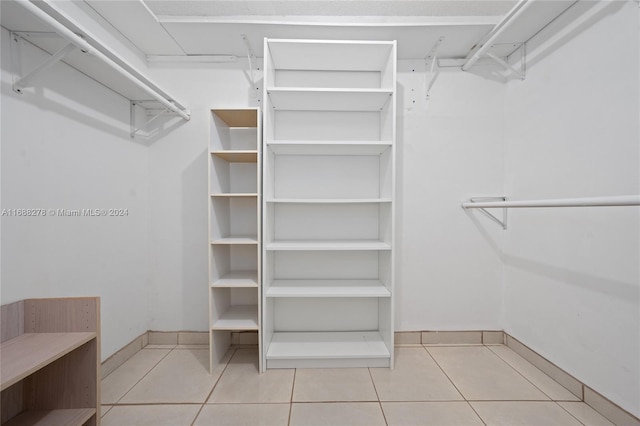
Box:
[262, 39, 396, 368]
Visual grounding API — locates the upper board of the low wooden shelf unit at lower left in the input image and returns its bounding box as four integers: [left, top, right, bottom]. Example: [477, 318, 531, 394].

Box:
[0, 332, 96, 390]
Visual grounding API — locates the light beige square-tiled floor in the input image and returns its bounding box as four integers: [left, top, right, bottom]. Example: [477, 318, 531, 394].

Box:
[102, 345, 612, 426]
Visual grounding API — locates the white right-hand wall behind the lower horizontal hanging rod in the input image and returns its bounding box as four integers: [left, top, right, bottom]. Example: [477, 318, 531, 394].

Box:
[504, 1, 640, 416]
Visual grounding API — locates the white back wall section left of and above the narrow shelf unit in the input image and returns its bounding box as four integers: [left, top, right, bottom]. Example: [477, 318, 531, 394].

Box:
[149, 60, 261, 331]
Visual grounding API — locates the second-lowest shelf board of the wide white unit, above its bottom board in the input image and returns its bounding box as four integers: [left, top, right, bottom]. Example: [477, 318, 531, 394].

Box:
[266, 280, 391, 297]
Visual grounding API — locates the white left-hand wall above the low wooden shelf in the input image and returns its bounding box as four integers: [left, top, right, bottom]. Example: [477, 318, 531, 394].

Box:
[1, 28, 149, 359]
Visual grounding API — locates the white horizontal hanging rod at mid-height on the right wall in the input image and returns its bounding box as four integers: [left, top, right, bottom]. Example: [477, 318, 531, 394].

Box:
[462, 195, 640, 209]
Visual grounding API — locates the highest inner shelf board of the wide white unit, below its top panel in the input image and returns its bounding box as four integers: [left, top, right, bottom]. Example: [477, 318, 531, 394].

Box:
[267, 87, 393, 111]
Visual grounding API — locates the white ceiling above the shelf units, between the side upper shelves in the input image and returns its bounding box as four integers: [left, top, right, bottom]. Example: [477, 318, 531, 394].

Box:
[85, 0, 516, 59]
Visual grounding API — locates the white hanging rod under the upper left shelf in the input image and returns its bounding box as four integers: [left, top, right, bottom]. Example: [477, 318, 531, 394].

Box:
[18, 0, 191, 121]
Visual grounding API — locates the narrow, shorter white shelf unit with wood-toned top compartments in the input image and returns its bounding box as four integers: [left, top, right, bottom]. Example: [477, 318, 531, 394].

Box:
[209, 108, 262, 372]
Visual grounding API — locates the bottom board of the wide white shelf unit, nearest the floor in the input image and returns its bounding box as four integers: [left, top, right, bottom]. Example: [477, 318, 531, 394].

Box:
[267, 331, 390, 359]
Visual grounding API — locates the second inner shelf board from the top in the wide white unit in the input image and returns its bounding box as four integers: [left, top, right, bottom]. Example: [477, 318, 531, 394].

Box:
[267, 140, 392, 155]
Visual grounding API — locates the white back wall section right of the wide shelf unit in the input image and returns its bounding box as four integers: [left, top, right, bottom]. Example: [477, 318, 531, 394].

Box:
[396, 61, 504, 331]
